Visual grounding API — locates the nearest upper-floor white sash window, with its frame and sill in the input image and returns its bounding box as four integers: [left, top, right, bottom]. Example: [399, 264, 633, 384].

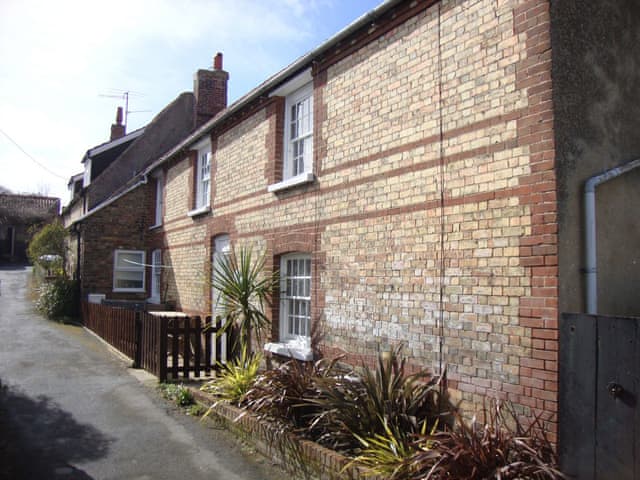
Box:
[267, 70, 315, 192]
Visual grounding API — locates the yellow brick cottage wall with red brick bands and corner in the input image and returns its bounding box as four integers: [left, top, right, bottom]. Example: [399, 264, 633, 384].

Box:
[159, 0, 557, 434]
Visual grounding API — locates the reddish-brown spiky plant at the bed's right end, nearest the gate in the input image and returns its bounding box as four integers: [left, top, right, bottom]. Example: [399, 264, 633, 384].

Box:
[400, 401, 566, 480]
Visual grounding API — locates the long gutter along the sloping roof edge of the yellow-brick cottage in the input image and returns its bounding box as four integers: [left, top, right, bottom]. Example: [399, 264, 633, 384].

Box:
[144, 0, 404, 175]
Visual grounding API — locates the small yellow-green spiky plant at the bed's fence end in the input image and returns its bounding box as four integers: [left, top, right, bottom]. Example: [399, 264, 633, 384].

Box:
[201, 348, 262, 404]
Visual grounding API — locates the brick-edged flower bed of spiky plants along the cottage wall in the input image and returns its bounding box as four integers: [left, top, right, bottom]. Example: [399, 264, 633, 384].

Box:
[192, 347, 564, 480]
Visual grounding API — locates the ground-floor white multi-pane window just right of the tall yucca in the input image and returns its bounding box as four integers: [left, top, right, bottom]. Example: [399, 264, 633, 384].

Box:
[280, 254, 311, 346]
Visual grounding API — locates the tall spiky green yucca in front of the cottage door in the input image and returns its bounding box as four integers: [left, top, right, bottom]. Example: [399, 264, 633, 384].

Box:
[213, 247, 278, 353]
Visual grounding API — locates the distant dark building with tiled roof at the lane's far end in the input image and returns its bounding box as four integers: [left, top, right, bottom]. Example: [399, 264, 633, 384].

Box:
[0, 193, 60, 262]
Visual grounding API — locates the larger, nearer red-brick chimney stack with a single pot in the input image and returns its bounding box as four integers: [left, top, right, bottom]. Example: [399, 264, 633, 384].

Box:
[193, 52, 229, 127]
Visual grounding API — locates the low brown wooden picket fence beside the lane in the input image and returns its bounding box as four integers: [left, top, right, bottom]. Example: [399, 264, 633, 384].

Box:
[82, 302, 231, 382]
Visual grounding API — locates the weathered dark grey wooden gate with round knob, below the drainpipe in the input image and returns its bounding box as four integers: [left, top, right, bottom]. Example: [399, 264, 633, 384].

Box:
[559, 314, 640, 480]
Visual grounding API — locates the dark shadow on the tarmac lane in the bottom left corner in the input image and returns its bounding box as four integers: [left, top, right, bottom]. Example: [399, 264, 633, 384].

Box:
[0, 381, 113, 480]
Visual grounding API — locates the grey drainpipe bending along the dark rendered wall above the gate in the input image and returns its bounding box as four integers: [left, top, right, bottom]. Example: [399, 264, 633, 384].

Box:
[584, 158, 640, 315]
